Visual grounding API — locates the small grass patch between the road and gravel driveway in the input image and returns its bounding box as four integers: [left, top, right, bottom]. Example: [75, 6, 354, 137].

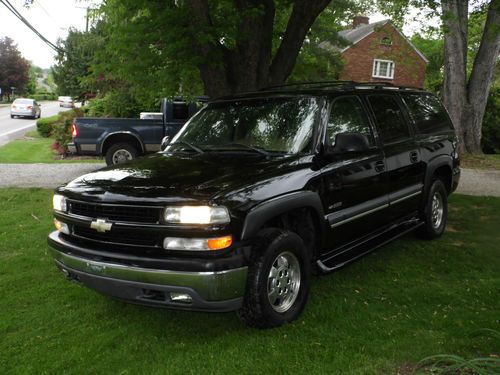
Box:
[0, 136, 102, 163]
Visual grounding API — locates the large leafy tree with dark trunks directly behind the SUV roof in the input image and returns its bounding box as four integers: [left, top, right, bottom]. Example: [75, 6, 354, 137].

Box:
[93, 0, 369, 97]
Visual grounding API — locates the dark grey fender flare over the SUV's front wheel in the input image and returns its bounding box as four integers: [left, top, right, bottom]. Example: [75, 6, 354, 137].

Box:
[241, 191, 325, 240]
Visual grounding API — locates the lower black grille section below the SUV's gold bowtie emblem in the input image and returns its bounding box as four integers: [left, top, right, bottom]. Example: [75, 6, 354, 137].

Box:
[73, 225, 159, 247]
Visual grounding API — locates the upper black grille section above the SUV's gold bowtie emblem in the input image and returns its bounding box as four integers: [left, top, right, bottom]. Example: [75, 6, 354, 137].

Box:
[68, 200, 161, 223]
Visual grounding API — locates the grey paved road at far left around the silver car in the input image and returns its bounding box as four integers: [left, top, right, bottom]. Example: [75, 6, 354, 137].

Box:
[0, 101, 68, 146]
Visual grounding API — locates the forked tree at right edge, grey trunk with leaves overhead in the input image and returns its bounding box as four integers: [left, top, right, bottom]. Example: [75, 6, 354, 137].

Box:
[379, 0, 500, 154]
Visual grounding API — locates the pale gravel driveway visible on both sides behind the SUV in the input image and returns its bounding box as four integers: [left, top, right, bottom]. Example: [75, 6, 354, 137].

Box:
[0, 163, 500, 197]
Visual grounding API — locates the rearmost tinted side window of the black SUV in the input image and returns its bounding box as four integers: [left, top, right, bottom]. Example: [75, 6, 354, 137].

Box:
[401, 94, 452, 134]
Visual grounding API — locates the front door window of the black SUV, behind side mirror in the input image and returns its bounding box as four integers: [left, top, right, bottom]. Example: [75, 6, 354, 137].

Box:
[328, 96, 374, 146]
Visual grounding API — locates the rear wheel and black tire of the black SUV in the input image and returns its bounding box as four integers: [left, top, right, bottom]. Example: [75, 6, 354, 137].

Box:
[418, 180, 448, 240]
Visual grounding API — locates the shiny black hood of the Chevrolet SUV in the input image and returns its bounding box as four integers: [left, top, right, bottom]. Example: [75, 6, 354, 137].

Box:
[58, 153, 316, 204]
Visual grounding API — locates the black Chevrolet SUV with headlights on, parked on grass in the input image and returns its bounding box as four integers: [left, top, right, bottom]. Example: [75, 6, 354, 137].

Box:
[48, 82, 460, 327]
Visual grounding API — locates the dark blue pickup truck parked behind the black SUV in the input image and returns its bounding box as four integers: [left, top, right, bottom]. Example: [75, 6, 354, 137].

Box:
[68, 99, 199, 165]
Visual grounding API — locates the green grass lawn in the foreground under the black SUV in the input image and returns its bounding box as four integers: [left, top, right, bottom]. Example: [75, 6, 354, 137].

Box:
[0, 189, 500, 374]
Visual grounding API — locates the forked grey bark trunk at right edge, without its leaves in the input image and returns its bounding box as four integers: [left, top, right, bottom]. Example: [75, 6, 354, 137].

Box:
[441, 0, 500, 154]
